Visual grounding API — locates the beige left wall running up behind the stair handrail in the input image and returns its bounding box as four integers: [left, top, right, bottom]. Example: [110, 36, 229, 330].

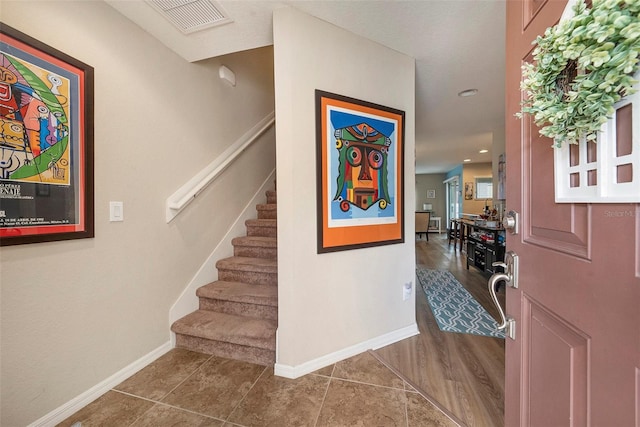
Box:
[0, 0, 275, 426]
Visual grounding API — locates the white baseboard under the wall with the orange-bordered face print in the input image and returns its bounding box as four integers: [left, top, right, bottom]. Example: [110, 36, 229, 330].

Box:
[274, 323, 420, 379]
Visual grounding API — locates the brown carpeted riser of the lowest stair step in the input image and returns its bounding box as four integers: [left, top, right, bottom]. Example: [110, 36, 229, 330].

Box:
[176, 334, 276, 366]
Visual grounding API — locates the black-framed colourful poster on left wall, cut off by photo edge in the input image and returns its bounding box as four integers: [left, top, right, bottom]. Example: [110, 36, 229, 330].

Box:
[0, 24, 94, 246]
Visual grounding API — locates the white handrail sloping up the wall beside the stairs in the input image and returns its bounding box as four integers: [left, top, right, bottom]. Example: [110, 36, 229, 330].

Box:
[166, 111, 276, 223]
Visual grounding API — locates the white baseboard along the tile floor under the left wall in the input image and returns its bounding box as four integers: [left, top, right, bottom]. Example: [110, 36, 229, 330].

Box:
[28, 341, 173, 427]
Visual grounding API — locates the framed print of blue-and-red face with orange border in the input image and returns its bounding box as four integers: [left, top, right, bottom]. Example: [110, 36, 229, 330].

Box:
[315, 90, 404, 253]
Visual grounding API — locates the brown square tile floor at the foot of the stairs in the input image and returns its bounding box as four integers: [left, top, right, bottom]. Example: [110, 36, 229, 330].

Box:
[53, 349, 457, 427]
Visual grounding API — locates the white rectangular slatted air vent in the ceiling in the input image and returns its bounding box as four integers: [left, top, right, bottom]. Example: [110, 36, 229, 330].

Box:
[146, 0, 233, 34]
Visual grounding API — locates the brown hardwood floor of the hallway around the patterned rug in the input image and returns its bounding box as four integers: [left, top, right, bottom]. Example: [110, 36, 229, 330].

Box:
[375, 234, 504, 427]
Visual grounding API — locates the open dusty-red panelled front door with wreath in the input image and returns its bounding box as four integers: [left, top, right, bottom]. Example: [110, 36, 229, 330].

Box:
[505, 0, 640, 427]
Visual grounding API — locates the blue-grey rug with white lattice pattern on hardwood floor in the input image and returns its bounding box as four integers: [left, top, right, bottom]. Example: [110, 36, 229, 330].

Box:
[416, 268, 504, 338]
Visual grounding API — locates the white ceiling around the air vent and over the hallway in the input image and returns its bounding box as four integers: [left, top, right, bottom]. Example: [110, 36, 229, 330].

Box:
[106, 0, 505, 173]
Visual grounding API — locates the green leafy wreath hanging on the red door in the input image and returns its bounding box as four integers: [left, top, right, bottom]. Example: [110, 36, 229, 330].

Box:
[517, 0, 640, 147]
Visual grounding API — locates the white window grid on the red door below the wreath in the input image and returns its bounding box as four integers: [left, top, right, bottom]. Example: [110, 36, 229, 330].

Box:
[554, 84, 640, 203]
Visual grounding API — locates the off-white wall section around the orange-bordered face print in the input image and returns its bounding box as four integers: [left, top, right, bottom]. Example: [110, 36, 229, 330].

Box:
[274, 8, 415, 376]
